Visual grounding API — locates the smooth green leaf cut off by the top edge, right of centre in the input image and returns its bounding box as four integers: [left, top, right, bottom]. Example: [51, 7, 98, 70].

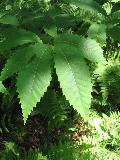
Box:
[69, 0, 106, 15]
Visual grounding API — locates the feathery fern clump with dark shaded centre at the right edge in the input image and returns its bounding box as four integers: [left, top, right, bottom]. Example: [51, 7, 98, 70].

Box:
[94, 61, 120, 106]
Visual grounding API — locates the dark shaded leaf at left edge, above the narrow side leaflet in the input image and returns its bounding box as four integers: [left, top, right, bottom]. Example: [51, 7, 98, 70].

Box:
[0, 26, 41, 53]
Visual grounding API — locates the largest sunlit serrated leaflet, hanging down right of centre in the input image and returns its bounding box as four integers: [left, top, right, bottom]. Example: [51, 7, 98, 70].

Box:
[55, 45, 92, 120]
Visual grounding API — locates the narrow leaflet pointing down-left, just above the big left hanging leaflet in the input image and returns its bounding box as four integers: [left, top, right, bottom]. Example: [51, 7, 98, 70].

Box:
[0, 43, 50, 81]
